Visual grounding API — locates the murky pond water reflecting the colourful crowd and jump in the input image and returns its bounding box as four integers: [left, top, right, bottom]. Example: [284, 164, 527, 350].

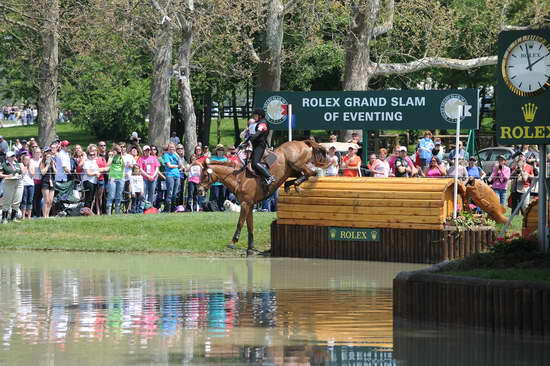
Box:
[0, 251, 548, 366]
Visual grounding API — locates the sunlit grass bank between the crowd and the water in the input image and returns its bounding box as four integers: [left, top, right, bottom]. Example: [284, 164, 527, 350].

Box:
[0, 212, 275, 255]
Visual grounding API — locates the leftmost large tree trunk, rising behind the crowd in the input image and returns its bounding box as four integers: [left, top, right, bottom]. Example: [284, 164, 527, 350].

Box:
[38, 0, 59, 146]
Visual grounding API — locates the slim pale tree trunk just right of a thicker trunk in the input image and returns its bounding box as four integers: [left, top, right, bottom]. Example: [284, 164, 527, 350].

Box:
[178, 21, 197, 159]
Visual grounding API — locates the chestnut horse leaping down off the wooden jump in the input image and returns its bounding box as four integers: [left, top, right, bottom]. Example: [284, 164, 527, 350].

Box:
[195, 140, 328, 254]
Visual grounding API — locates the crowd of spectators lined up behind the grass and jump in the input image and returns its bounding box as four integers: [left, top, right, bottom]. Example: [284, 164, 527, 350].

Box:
[0, 131, 539, 223]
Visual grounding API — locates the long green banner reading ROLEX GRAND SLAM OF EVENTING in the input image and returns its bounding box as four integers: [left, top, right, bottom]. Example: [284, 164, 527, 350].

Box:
[254, 89, 479, 130]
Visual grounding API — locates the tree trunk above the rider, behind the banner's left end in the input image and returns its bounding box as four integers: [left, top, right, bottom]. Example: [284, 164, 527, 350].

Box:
[256, 0, 284, 91]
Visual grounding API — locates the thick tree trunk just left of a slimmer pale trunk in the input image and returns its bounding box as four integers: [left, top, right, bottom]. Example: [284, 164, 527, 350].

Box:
[149, 22, 174, 150]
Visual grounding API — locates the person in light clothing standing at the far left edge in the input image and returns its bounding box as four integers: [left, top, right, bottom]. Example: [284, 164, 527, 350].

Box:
[0, 151, 23, 224]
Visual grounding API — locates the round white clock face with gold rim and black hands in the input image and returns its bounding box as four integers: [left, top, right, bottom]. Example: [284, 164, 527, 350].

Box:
[501, 35, 550, 96]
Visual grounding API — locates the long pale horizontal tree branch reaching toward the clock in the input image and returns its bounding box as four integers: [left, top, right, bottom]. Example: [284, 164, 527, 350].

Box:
[369, 56, 497, 76]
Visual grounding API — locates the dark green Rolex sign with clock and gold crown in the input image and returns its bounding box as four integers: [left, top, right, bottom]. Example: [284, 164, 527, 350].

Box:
[496, 29, 550, 145]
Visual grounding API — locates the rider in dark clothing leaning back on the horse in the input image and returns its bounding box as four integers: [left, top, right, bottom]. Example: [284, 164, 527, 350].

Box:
[239, 109, 276, 185]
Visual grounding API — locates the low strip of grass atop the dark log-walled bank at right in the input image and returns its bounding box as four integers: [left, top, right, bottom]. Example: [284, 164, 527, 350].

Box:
[442, 268, 550, 283]
